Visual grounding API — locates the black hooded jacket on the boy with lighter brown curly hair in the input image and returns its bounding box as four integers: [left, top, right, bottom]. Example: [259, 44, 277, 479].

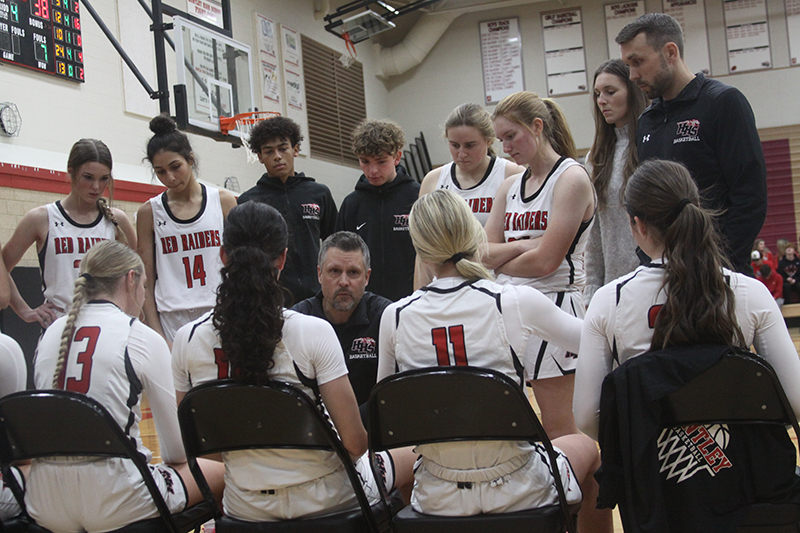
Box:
[336, 165, 419, 302]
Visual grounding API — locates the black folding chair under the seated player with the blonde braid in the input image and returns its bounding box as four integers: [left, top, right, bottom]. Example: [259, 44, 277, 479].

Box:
[0, 390, 211, 533]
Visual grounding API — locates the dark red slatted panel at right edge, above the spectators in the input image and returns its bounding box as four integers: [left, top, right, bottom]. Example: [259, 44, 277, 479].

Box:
[759, 139, 797, 253]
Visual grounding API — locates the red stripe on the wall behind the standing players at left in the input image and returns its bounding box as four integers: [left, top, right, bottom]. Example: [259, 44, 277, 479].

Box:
[0, 163, 166, 203]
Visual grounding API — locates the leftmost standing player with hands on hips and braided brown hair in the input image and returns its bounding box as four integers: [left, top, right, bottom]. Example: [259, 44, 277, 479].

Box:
[3, 139, 136, 328]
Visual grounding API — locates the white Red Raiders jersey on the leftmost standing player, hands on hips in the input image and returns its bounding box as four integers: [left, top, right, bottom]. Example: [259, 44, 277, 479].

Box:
[39, 201, 116, 312]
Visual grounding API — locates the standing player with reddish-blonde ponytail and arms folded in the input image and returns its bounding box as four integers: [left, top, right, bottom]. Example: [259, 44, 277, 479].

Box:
[485, 92, 596, 439]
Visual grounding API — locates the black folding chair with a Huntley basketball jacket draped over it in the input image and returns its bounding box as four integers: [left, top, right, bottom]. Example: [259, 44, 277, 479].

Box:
[661, 350, 800, 533]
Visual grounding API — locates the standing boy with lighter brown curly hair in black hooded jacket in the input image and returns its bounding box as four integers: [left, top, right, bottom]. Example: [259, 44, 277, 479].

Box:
[336, 120, 419, 301]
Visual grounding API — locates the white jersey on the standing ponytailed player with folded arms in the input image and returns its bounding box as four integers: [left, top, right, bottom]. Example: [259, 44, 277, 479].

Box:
[497, 157, 594, 292]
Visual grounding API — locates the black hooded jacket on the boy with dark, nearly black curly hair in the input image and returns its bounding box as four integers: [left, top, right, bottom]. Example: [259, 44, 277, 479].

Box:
[238, 172, 336, 307]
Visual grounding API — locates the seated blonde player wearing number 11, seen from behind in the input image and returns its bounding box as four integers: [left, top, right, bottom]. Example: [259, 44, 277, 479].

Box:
[378, 189, 612, 532]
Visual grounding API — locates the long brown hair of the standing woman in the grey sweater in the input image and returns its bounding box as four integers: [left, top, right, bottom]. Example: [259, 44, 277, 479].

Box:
[589, 59, 647, 209]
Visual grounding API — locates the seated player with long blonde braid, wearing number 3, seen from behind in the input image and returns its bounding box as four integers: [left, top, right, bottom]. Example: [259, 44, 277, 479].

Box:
[25, 240, 224, 533]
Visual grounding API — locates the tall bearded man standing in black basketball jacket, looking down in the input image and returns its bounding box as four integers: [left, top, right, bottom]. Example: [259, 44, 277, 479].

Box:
[616, 13, 767, 276]
